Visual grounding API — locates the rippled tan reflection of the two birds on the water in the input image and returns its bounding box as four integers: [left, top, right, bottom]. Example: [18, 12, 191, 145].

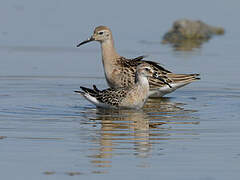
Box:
[80, 98, 198, 173]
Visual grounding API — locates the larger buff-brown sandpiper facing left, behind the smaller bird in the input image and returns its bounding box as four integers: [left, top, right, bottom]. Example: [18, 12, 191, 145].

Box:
[77, 26, 200, 97]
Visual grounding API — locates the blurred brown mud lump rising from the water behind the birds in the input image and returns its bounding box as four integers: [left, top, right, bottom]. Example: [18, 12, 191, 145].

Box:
[162, 19, 224, 48]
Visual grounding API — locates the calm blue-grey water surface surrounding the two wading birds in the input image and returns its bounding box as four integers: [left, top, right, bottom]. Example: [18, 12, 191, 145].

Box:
[0, 0, 240, 180]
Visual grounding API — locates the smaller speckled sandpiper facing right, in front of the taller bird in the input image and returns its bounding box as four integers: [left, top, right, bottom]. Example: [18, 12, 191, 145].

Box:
[75, 63, 171, 109]
